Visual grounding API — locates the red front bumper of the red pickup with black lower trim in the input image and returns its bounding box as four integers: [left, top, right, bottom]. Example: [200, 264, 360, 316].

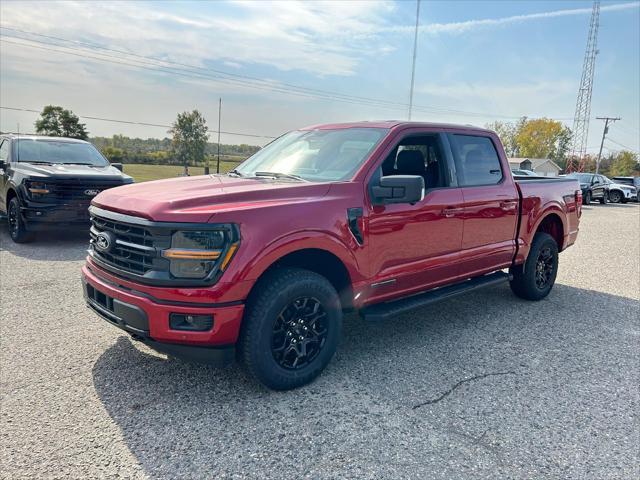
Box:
[82, 265, 244, 364]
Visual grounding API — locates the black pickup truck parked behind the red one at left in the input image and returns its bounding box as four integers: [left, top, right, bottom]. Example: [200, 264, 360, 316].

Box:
[0, 135, 133, 243]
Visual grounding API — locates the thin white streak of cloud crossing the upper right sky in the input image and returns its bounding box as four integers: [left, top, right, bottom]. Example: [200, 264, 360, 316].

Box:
[387, 2, 640, 35]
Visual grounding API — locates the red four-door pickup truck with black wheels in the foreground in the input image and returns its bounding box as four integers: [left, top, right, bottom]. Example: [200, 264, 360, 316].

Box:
[82, 121, 582, 389]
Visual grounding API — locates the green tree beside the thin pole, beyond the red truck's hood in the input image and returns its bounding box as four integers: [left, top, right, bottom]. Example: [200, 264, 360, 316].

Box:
[169, 110, 209, 175]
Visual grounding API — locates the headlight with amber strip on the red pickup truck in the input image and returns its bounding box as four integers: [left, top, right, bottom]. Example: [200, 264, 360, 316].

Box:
[162, 228, 238, 278]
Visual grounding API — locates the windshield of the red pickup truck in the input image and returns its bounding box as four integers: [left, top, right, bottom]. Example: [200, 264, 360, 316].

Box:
[234, 128, 388, 182]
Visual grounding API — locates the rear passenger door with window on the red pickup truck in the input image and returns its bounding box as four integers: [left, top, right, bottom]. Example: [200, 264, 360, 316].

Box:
[449, 133, 519, 277]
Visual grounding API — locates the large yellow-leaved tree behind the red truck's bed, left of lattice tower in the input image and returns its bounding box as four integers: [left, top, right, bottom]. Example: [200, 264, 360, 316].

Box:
[515, 118, 571, 162]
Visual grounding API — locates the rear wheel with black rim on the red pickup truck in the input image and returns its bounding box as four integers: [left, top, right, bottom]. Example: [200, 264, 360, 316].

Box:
[509, 232, 558, 300]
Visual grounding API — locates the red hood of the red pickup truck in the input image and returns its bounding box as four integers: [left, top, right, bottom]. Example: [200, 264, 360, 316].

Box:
[91, 175, 330, 223]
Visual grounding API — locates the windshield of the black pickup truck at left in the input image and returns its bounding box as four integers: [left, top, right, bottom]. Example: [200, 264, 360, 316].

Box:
[16, 139, 109, 167]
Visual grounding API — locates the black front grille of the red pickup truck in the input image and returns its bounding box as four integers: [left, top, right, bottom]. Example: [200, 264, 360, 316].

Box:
[89, 215, 171, 275]
